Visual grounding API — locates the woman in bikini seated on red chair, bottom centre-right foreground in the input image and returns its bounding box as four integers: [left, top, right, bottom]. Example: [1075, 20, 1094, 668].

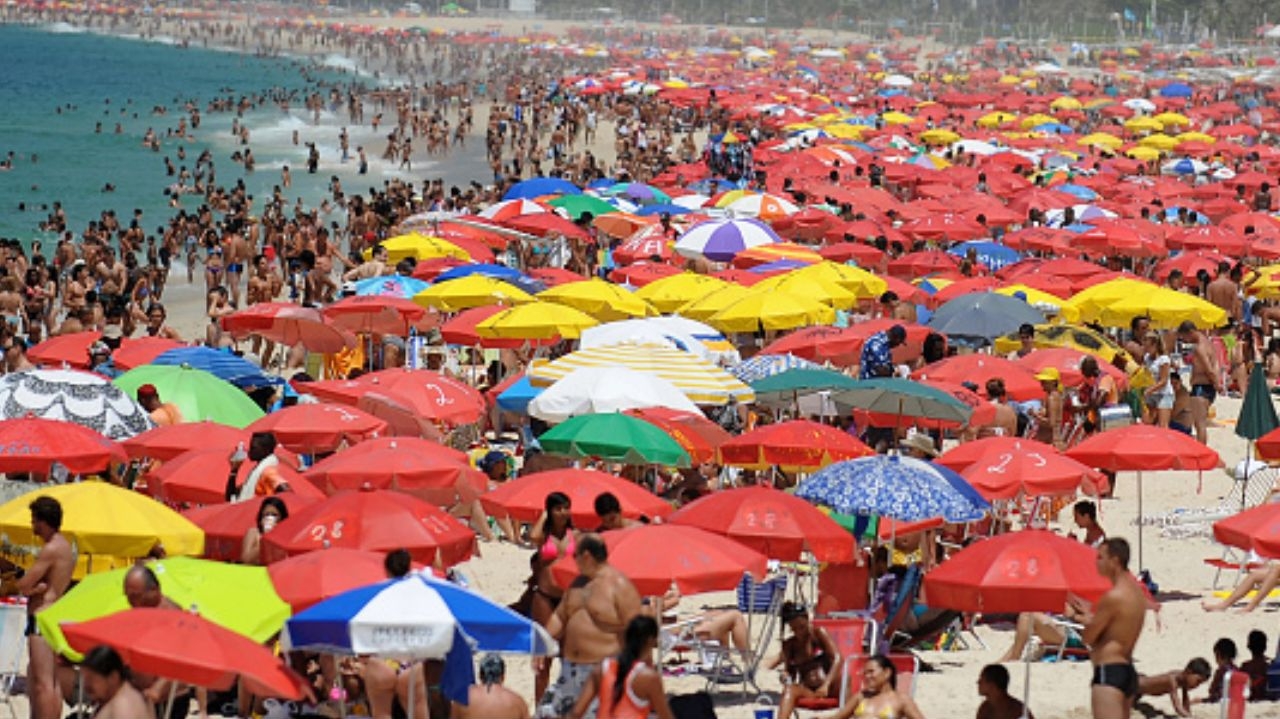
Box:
[769, 601, 844, 719]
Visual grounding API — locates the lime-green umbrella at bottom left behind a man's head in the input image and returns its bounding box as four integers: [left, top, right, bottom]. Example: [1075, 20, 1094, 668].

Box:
[36, 557, 291, 661]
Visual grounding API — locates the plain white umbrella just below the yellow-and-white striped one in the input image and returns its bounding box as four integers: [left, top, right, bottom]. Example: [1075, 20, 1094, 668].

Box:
[527, 367, 698, 425]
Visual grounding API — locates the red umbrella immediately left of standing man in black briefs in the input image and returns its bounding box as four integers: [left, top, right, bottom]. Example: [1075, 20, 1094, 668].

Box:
[924, 530, 1111, 614]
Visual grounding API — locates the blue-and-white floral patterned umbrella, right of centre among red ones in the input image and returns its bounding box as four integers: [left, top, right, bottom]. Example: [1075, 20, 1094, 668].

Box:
[796, 455, 991, 522]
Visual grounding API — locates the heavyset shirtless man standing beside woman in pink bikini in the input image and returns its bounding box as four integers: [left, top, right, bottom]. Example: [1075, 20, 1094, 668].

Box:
[538, 535, 640, 719]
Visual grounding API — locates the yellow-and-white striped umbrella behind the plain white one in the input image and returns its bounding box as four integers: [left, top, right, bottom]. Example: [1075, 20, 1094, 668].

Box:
[529, 343, 755, 404]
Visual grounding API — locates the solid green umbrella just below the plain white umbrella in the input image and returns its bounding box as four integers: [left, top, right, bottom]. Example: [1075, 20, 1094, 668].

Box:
[538, 413, 689, 467]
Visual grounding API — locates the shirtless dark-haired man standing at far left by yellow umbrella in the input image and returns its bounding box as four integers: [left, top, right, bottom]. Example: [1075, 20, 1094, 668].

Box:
[18, 496, 76, 719]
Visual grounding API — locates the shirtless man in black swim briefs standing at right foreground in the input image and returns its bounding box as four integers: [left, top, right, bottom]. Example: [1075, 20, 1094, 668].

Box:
[1066, 537, 1147, 719]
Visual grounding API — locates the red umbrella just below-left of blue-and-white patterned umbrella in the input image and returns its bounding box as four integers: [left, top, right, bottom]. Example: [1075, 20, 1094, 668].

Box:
[669, 486, 854, 563]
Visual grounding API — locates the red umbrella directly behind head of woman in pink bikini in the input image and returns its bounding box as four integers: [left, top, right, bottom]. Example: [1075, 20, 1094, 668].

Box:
[480, 470, 672, 527]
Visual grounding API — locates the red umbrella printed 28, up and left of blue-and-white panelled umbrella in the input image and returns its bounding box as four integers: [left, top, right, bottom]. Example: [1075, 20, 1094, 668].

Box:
[262, 487, 475, 567]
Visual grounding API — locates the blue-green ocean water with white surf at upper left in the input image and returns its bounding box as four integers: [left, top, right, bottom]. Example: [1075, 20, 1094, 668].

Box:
[0, 24, 488, 243]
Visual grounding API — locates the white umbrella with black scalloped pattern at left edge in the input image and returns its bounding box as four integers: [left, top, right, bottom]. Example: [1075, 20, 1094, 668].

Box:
[0, 370, 155, 440]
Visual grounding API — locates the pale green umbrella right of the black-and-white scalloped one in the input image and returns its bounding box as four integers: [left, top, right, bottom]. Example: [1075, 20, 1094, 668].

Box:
[111, 365, 264, 430]
